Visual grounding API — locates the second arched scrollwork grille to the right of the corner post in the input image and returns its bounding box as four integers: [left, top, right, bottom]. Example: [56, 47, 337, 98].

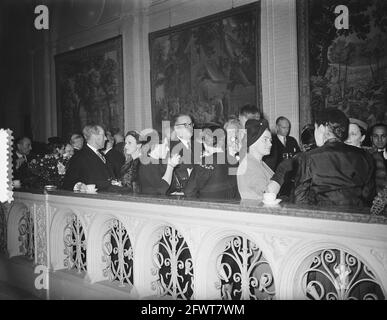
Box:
[102, 219, 133, 287]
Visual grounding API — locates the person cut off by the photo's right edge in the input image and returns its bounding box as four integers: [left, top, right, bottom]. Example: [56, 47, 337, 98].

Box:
[369, 123, 387, 192]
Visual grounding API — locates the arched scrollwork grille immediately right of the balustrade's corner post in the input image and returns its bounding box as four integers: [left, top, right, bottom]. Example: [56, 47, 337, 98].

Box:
[64, 215, 87, 273]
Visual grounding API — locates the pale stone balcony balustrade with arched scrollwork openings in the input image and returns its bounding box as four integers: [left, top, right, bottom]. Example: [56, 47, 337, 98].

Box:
[0, 191, 387, 300]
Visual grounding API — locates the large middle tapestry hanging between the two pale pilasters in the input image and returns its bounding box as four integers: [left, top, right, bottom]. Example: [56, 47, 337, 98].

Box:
[149, 3, 261, 130]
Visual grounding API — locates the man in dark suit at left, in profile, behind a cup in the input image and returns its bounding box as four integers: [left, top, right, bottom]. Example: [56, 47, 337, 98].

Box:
[63, 125, 114, 191]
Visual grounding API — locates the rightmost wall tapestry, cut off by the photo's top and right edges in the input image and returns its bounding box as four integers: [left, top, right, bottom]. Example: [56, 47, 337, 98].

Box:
[297, 0, 387, 130]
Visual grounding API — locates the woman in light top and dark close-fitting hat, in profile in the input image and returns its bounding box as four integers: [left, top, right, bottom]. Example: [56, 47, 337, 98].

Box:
[237, 119, 273, 200]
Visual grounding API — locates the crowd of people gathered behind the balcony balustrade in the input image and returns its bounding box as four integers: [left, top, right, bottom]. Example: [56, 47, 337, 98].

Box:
[13, 105, 387, 214]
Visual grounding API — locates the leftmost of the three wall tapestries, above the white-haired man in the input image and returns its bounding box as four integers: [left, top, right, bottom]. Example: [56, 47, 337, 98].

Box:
[55, 37, 124, 138]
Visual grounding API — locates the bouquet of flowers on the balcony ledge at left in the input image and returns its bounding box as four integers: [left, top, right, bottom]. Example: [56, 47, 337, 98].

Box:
[29, 154, 68, 187]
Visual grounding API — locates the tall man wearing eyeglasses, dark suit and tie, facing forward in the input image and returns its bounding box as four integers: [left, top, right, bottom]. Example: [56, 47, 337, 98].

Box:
[169, 114, 201, 194]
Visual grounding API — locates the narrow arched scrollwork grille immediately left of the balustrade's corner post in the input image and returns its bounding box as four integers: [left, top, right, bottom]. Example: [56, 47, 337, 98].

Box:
[18, 209, 35, 260]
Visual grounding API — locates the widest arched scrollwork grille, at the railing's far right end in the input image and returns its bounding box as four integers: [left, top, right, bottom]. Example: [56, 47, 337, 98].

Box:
[301, 249, 385, 300]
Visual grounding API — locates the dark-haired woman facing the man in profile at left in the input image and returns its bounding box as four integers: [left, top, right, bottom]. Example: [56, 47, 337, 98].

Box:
[117, 131, 144, 192]
